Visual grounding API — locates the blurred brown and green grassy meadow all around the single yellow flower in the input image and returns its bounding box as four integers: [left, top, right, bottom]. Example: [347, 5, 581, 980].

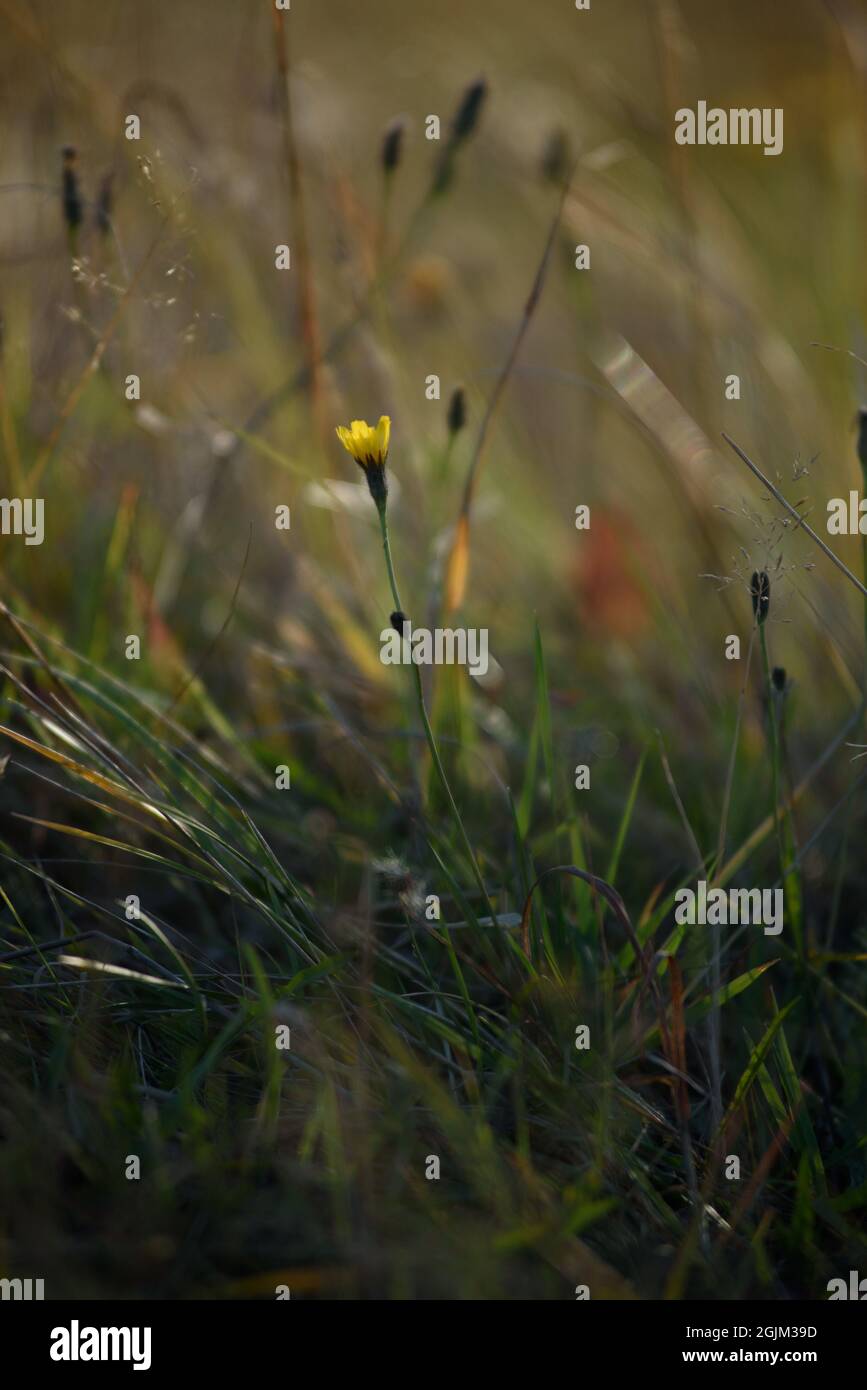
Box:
[0, 0, 867, 1297]
